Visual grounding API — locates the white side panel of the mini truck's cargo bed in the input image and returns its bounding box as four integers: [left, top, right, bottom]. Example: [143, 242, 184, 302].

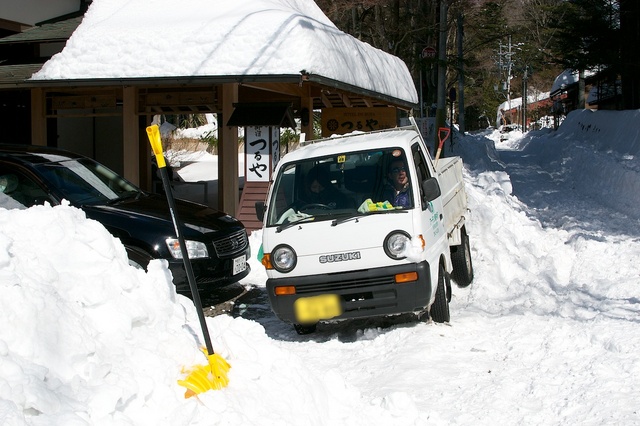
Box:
[436, 157, 467, 245]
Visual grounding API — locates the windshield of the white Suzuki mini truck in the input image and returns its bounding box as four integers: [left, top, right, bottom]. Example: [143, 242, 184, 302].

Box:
[266, 147, 414, 226]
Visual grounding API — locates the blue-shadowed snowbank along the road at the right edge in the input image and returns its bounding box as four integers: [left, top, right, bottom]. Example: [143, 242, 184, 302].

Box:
[502, 110, 640, 218]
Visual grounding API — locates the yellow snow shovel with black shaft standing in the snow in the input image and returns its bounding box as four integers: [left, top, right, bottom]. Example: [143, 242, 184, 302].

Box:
[147, 124, 231, 398]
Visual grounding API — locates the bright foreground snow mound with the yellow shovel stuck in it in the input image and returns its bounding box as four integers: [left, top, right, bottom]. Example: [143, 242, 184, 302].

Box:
[0, 206, 396, 425]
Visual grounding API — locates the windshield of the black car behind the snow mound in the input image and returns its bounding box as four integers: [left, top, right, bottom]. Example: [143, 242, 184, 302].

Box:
[37, 159, 141, 205]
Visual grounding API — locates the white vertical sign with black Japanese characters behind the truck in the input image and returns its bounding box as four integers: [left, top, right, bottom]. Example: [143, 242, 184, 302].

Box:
[244, 126, 280, 182]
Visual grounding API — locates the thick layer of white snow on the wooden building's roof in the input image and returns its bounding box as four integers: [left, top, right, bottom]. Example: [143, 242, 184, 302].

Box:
[32, 0, 418, 103]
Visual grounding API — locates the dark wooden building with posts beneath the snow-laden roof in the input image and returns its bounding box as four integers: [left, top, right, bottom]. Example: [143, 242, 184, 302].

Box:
[0, 0, 417, 231]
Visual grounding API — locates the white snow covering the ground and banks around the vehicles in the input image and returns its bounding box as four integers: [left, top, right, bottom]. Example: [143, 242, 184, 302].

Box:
[0, 111, 640, 426]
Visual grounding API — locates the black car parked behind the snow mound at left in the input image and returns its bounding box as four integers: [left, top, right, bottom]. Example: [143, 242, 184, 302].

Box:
[0, 144, 251, 295]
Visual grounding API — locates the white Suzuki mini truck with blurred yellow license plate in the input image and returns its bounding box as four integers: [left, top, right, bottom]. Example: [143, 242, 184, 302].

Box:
[256, 121, 473, 334]
